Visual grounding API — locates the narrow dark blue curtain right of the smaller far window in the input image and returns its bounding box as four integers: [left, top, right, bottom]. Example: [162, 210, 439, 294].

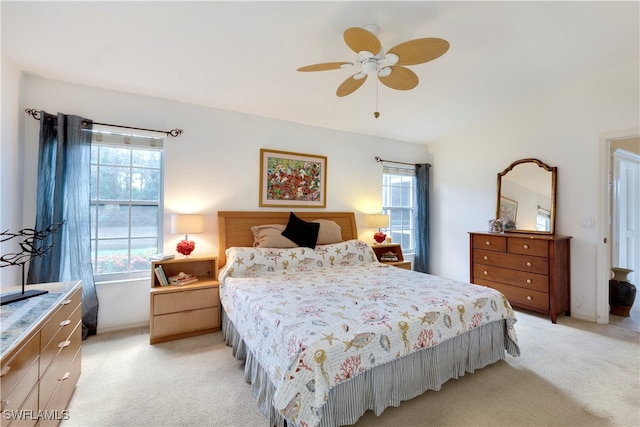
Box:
[413, 163, 431, 273]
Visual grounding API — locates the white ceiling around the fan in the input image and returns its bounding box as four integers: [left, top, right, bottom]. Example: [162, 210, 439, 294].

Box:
[1, 1, 640, 143]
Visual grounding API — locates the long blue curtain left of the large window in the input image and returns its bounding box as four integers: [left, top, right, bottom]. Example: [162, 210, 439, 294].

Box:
[27, 111, 98, 339]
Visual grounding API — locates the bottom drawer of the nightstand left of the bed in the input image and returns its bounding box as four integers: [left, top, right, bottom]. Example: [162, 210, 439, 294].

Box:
[152, 308, 220, 337]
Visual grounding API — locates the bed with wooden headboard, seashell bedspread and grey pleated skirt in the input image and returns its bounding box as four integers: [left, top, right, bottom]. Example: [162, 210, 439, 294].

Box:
[218, 211, 520, 427]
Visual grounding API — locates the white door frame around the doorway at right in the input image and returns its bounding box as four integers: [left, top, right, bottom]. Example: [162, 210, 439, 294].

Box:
[596, 128, 640, 324]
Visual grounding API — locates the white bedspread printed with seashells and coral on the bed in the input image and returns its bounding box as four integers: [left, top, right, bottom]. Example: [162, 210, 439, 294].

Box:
[220, 240, 517, 426]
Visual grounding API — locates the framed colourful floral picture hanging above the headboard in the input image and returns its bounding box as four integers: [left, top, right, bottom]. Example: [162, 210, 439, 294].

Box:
[260, 148, 327, 208]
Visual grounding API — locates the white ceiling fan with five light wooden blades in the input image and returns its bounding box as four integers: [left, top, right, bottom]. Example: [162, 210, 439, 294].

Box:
[298, 25, 449, 96]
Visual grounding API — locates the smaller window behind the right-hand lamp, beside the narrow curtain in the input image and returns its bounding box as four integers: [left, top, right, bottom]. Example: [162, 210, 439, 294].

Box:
[382, 166, 416, 254]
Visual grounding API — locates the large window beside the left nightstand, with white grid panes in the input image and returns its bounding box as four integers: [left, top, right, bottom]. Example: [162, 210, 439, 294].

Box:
[91, 129, 164, 281]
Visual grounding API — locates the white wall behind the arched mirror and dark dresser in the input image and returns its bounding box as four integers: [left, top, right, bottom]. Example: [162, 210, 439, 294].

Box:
[429, 60, 640, 321]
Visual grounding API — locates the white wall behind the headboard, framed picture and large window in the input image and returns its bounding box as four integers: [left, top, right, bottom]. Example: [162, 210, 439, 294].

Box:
[10, 76, 428, 332]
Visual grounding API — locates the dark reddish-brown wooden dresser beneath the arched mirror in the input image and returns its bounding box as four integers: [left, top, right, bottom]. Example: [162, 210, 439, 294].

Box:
[469, 232, 571, 323]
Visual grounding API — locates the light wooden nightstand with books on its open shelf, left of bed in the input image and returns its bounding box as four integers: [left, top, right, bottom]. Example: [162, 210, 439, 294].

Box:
[149, 256, 220, 344]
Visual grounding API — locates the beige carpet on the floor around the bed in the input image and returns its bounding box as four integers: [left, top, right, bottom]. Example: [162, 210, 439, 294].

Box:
[61, 312, 640, 427]
